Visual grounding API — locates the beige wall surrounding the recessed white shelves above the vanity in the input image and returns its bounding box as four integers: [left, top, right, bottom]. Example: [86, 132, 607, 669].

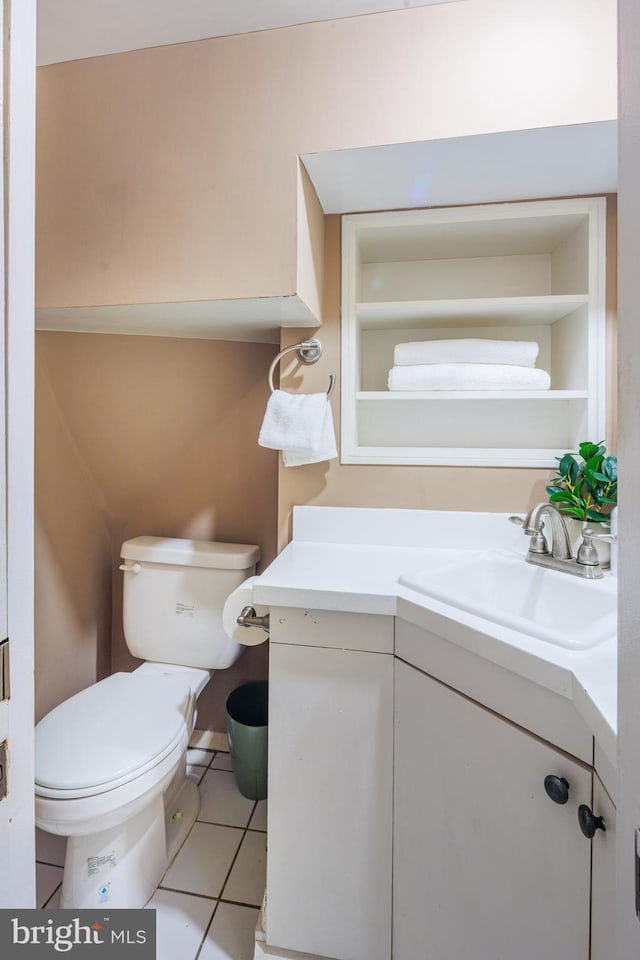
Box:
[278, 204, 616, 549]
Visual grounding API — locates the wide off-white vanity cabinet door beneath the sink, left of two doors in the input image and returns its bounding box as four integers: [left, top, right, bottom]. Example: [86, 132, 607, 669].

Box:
[393, 661, 592, 960]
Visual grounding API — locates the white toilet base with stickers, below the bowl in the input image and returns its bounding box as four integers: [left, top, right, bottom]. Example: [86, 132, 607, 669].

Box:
[60, 771, 200, 910]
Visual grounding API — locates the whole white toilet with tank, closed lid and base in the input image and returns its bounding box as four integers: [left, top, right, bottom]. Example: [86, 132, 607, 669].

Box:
[35, 537, 260, 909]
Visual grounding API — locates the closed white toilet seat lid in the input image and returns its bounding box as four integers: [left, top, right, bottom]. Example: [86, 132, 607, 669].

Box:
[35, 670, 194, 800]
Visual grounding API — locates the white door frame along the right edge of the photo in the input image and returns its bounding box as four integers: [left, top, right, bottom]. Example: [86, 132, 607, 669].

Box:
[616, 0, 640, 960]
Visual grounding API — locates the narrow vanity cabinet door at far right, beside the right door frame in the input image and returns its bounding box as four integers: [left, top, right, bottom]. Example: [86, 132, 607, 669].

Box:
[591, 776, 616, 960]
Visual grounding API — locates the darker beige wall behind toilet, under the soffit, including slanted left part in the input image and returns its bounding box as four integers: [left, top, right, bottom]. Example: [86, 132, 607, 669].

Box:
[36, 333, 277, 729]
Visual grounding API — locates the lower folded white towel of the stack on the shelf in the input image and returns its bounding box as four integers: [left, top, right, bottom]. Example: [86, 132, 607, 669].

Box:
[388, 363, 551, 390]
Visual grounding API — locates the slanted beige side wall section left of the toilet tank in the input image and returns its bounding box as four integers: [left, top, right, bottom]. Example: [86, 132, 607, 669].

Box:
[35, 337, 111, 720]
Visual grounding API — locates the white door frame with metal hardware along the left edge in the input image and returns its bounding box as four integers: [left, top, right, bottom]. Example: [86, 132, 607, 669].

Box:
[0, 0, 36, 907]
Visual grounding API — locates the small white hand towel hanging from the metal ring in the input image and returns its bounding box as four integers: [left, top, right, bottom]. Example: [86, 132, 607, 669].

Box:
[258, 390, 338, 467]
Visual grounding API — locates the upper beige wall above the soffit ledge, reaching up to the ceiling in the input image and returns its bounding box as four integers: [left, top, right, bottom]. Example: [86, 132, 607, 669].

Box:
[37, 0, 616, 307]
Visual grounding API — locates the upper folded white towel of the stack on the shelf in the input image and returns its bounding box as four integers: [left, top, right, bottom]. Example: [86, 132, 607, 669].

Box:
[393, 339, 540, 367]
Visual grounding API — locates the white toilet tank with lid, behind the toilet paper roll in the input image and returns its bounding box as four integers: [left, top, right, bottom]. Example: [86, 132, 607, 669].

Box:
[120, 537, 260, 670]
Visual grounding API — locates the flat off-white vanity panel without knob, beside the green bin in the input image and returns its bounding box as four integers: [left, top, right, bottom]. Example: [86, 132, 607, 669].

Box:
[266, 643, 396, 960]
